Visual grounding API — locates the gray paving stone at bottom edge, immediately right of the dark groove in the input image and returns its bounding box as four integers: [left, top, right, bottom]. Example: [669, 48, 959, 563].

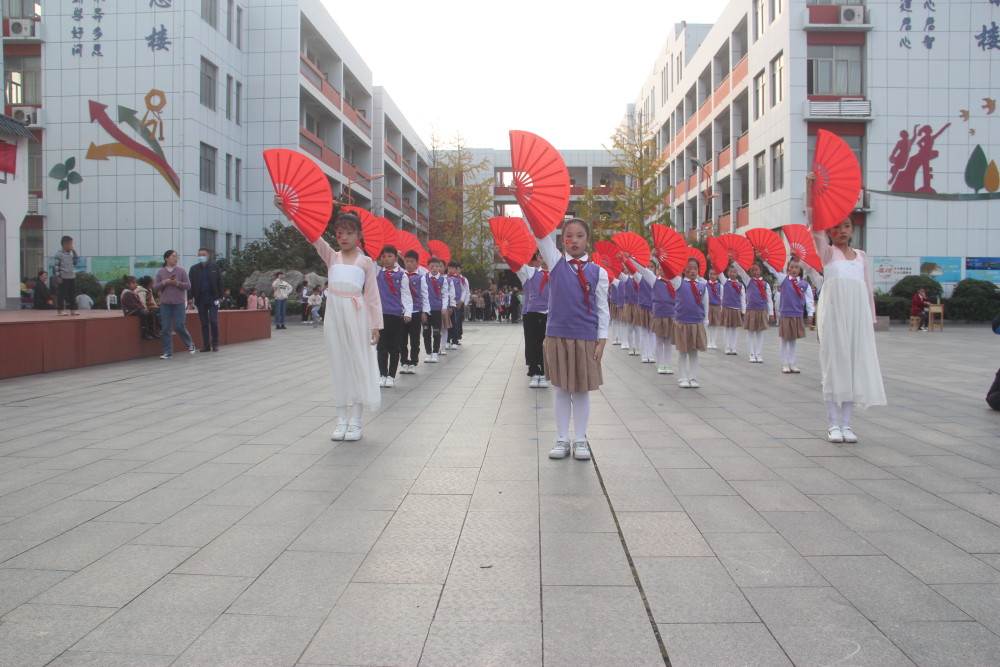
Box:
[659, 623, 792, 667]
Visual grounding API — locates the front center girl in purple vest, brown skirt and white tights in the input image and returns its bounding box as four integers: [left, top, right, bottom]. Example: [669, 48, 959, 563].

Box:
[538, 218, 610, 461]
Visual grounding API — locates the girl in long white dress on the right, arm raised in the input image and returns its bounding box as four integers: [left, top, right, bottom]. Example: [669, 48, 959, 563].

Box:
[806, 173, 886, 442]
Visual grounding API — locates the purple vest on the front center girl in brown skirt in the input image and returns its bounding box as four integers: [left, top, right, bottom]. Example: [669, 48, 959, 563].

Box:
[545, 258, 602, 340]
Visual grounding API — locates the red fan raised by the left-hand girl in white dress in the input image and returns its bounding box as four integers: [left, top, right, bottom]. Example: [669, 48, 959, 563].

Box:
[264, 148, 333, 243]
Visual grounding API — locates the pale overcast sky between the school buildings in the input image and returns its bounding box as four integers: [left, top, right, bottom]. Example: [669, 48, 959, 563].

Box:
[323, 0, 726, 149]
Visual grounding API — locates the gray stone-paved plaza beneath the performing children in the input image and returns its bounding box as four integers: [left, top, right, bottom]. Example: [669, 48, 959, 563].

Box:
[0, 322, 1000, 667]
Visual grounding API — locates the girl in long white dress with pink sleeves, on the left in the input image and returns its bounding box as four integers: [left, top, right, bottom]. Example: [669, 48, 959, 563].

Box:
[274, 202, 382, 440]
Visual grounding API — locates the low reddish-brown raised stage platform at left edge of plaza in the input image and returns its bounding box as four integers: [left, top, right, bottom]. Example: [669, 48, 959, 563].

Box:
[0, 310, 271, 379]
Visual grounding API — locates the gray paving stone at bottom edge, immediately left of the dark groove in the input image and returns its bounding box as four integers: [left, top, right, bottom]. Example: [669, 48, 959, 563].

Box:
[542, 586, 663, 666]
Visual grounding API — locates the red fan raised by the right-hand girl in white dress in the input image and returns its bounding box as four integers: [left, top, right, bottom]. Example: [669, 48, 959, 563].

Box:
[812, 130, 861, 230]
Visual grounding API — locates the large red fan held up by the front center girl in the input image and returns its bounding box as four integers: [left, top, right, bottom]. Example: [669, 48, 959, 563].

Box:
[510, 130, 569, 238]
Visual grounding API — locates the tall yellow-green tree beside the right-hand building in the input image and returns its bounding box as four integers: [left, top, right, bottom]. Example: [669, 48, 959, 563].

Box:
[605, 114, 673, 234]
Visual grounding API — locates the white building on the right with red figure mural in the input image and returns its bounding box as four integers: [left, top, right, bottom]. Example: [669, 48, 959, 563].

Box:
[634, 0, 1000, 287]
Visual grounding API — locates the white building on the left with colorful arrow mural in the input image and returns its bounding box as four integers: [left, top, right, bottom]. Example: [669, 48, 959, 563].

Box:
[3, 0, 428, 300]
